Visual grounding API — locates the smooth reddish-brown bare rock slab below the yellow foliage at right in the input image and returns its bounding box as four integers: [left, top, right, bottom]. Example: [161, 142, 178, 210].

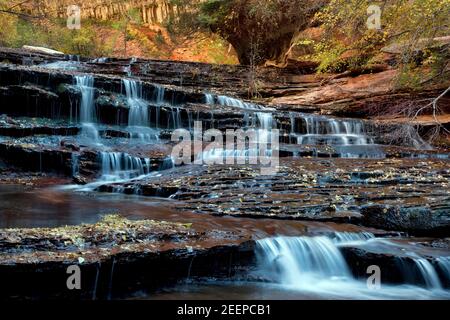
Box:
[272, 70, 450, 117]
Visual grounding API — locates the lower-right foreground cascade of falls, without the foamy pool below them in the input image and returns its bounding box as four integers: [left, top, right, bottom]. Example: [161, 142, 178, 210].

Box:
[256, 232, 450, 291]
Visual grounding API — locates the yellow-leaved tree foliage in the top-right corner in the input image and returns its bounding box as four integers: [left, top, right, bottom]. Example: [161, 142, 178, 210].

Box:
[315, 0, 450, 74]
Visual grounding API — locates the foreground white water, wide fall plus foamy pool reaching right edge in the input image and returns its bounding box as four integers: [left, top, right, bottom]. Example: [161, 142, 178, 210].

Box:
[256, 233, 450, 299]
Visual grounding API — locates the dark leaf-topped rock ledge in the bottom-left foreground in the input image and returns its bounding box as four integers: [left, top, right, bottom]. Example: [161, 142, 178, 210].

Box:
[0, 216, 254, 299]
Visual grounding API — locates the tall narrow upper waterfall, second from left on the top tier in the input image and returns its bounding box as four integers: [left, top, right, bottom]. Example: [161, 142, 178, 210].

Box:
[122, 79, 148, 127]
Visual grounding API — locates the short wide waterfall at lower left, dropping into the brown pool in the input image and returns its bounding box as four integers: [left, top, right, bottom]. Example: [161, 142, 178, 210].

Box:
[100, 152, 150, 181]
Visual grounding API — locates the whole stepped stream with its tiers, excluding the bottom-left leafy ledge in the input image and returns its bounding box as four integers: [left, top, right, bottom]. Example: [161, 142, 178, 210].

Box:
[0, 53, 450, 300]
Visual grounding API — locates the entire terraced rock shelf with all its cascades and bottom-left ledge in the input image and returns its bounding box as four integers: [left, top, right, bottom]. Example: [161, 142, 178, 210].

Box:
[0, 49, 450, 299]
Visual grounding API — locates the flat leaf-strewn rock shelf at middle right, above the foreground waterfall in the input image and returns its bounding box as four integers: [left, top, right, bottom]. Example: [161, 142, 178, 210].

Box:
[98, 158, 450, 232]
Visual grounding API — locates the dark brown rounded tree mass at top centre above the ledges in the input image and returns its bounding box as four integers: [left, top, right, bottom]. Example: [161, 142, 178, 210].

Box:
[199, 0, 327, 65]
